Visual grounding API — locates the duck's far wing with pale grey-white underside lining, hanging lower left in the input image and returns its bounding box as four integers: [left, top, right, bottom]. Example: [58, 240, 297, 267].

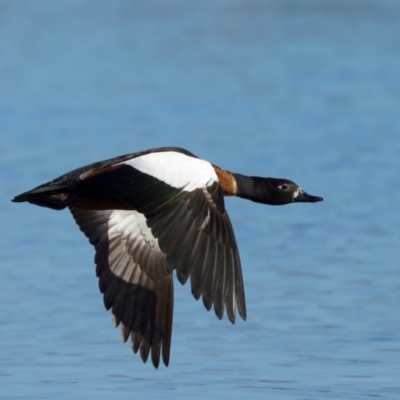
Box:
[70, 206, 173, 368]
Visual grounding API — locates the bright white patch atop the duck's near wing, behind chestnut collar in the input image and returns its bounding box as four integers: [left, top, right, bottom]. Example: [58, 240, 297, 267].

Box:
[121, 151, 218, 192]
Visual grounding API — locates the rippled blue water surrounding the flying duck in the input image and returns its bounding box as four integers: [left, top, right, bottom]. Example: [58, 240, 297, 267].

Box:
[0, 0, 400, 400]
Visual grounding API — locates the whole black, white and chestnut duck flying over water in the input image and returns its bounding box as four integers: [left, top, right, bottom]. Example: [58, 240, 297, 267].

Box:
[13, 147, 323, 368]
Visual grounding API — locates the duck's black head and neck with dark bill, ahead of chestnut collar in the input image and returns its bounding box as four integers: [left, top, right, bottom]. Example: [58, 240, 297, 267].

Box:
[238, 176, 323, 206]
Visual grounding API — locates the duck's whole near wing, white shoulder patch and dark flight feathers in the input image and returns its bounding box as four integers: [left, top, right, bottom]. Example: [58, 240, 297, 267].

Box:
[77, 151, 246, 323]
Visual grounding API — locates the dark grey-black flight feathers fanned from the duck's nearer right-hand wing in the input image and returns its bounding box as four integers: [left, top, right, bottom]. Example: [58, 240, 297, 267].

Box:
[147, 183, 246, 322]
